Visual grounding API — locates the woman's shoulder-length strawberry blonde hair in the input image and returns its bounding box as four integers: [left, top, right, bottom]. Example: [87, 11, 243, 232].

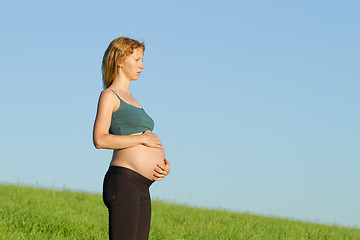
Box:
[101, 37, 145, 88]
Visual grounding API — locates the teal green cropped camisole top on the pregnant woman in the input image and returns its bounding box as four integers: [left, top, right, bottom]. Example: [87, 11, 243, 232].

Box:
[109, 89, 154, 135]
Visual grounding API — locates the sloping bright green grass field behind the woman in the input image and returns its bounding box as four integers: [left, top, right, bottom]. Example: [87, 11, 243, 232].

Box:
[0, 185, 360, 240]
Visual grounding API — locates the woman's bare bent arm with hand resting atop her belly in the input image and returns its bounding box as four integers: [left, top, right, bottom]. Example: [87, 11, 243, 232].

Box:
[93, 90, 163, 149]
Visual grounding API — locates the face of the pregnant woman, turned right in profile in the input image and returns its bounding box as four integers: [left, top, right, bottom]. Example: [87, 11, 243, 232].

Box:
[120, 48, 144, 81]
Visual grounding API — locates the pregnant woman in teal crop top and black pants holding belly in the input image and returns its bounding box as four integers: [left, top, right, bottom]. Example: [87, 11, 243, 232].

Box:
[93, 37, 170, 240]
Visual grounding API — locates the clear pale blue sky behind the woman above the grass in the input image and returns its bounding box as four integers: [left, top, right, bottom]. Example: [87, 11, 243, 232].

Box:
[0, 0, 360, 227]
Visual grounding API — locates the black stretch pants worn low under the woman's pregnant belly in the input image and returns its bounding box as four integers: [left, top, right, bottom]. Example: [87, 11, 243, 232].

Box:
[103, 166, 153, 240]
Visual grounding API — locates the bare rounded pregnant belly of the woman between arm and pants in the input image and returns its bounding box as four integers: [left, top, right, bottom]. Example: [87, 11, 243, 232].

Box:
[110, 133, 165, 180]
